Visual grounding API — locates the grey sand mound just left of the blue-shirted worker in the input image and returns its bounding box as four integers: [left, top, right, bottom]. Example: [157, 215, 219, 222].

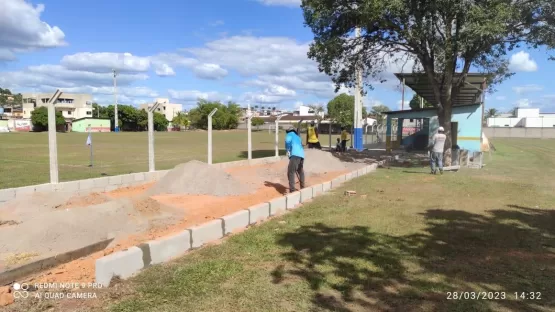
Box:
[147, 160, 255, 196]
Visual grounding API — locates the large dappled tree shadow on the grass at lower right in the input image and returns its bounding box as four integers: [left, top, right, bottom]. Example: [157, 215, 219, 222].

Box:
[272, 206, 555, 311]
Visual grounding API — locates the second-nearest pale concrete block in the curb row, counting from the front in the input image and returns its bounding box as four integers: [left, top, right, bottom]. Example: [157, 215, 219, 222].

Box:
[147, 230, 191, 264]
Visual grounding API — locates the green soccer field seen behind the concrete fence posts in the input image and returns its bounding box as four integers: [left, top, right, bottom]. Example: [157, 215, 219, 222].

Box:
[0, 130, 284, 189]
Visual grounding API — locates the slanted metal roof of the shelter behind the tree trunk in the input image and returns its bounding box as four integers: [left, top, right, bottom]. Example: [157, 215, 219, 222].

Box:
[395, 73, 488, 106]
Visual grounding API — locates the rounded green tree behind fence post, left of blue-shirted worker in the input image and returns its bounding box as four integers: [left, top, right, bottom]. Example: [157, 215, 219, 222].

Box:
[189, 99, 241, 130]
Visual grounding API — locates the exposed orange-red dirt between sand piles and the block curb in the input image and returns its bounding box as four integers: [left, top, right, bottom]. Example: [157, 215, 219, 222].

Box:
[23, 163, 346, 283]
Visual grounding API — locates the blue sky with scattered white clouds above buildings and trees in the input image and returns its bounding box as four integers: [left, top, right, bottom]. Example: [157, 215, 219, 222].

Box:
[0, 0, 555, 112]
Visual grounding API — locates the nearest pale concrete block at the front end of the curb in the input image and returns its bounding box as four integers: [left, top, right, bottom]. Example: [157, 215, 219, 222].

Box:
[95, 247, 144, 287]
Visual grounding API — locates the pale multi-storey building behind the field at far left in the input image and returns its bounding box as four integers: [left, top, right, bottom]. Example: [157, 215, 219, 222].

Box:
[22, 92, 93, 122]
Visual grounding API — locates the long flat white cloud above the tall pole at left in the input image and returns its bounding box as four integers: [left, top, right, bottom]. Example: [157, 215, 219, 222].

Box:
[61, 52, 150, 73]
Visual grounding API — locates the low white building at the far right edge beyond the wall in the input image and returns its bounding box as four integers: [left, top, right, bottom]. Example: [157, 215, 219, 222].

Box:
[487, 108, 555, 128]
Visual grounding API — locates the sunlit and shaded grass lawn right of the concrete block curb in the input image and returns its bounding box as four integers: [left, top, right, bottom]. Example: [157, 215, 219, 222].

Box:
[10, 139, 555, 312]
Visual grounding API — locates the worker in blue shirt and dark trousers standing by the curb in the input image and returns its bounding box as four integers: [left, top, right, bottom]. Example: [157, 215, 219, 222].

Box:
[285, 126, 304, 193]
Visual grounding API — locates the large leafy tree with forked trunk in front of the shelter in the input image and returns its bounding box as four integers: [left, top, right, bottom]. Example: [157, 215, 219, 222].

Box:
[302, 0, 555, 157]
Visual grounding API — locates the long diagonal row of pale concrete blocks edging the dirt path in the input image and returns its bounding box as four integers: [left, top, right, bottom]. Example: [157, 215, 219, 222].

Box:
[95, 163, 378, 286]
